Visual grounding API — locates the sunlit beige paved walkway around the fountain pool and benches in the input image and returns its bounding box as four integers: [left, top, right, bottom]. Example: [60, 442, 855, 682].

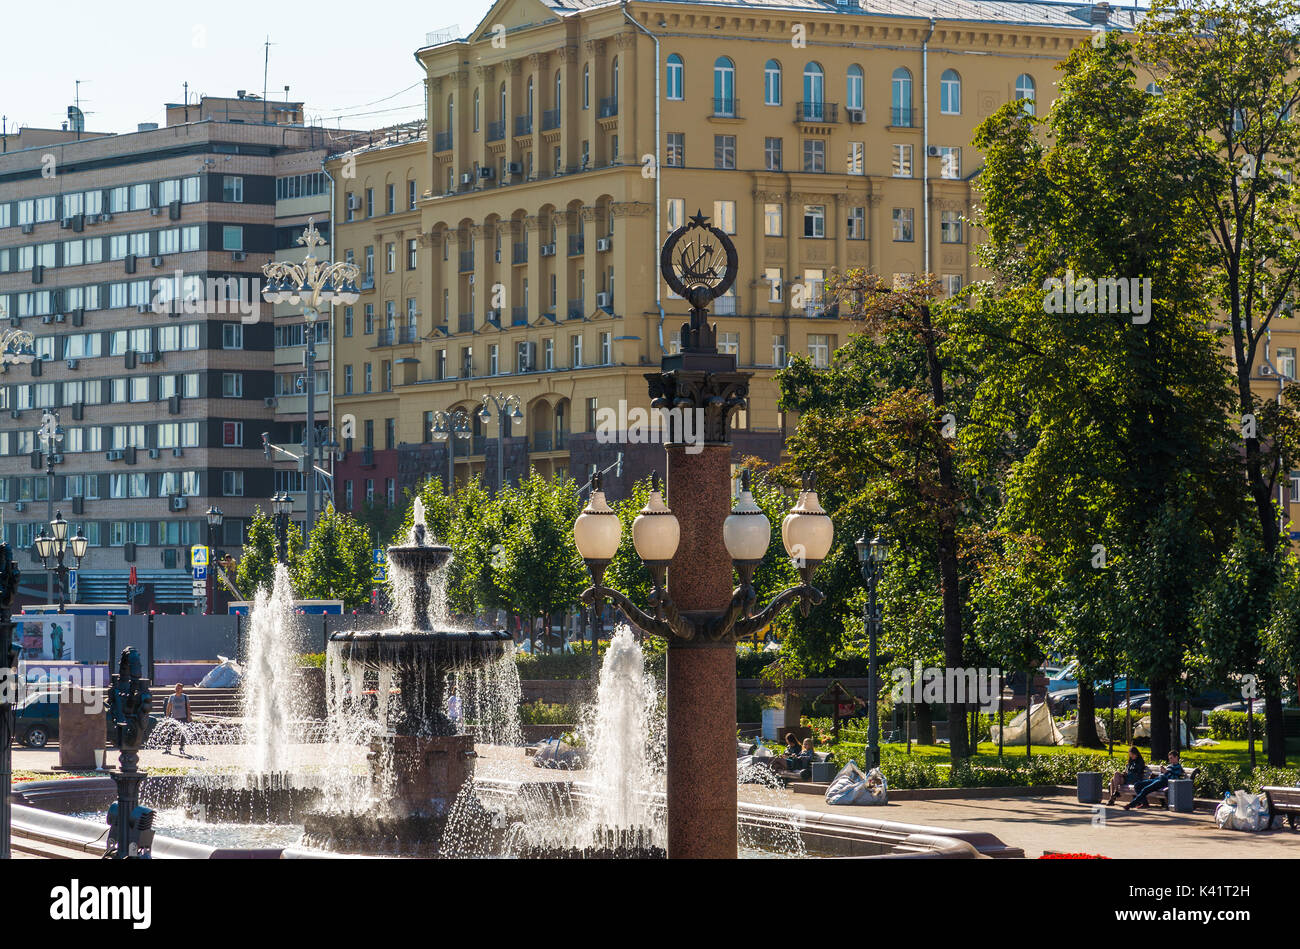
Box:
[13, 745, 1300, 859]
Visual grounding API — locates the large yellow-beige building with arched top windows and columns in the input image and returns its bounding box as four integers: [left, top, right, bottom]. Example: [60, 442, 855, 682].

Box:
[330, 0, 1295, 520]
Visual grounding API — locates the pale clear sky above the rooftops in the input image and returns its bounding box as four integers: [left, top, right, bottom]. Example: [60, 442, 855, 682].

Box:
[0, 0, 491, 133]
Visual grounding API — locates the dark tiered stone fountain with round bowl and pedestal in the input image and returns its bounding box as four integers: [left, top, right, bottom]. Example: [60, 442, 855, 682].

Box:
[306, 498, 512, 853]
